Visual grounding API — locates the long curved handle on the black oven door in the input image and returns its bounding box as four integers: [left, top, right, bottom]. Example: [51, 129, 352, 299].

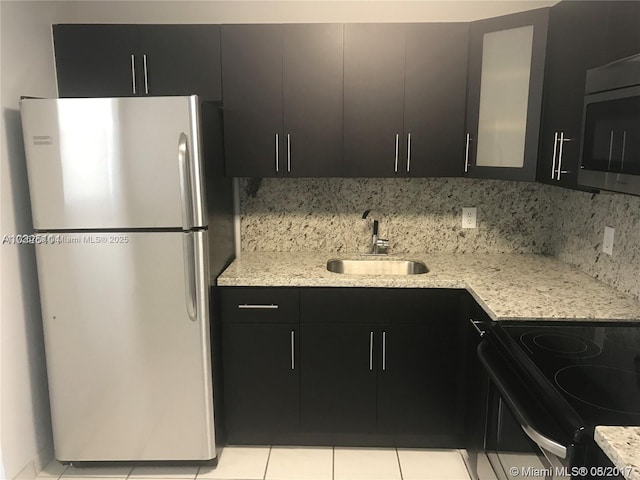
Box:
[478, 341, 567, 459]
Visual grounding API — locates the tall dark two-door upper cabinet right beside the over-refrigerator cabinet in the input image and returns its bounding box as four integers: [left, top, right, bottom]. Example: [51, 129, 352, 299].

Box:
[222, 24, 343, 177]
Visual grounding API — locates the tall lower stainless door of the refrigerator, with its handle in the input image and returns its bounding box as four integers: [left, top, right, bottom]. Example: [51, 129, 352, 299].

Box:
[36, 231, 216, 461]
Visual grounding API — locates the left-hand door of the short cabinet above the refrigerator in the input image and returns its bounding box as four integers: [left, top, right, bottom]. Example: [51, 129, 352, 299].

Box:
[53, 25, 139, 97]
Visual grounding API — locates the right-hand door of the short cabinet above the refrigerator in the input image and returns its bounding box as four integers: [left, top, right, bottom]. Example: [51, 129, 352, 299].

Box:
[136, 25, 222, 101]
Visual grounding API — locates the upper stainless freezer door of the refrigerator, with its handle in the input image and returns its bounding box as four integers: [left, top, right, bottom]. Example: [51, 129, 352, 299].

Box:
[20, 96, 207, 231]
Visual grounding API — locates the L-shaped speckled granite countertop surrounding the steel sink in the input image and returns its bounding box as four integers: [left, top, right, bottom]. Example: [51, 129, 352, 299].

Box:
[217, 252, 640, 321]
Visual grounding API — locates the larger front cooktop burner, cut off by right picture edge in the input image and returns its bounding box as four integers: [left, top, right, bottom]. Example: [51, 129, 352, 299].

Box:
[555, 365, 640, 415]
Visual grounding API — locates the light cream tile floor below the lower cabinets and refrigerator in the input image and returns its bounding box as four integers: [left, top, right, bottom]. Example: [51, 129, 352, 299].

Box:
[38, 446, 469, 480]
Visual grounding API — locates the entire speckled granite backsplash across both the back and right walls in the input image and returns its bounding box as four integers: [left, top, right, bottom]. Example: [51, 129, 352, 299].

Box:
[240, 178, 640, 299]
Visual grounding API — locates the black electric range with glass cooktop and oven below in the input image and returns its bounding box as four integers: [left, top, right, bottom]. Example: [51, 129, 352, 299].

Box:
[478, 321, 640, 480]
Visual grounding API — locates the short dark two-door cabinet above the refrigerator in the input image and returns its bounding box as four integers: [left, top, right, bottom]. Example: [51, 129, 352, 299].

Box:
[53, 24, 222, 101]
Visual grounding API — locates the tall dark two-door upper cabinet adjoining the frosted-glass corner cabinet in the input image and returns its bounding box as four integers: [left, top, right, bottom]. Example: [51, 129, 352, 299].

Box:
[343, 23, 468, 177]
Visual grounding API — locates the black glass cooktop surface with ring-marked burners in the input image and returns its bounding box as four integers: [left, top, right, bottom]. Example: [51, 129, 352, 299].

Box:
[501, 324, 640, 427]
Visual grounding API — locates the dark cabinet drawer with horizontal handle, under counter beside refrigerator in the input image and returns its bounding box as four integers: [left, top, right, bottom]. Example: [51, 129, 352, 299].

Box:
[220, 287, 299, 323]
